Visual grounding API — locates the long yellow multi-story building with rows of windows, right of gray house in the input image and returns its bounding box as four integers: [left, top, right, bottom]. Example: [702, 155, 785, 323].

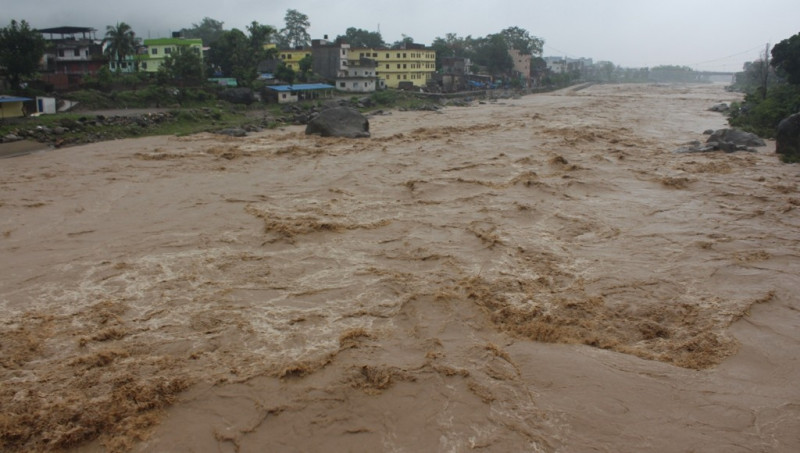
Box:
[347, 45, 436, 88]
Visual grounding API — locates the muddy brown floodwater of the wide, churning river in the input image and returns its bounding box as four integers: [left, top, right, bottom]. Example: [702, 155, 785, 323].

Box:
[0, 85, 800, 452]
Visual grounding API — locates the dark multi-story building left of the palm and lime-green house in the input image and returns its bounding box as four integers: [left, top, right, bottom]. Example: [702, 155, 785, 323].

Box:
[39, 27, 106, 89]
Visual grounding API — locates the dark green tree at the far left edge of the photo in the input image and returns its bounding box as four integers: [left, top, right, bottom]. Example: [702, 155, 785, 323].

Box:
[0, 20, 45, 90]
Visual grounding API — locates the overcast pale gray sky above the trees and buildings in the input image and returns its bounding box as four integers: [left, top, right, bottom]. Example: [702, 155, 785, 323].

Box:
[6, 0, 800, 71]
